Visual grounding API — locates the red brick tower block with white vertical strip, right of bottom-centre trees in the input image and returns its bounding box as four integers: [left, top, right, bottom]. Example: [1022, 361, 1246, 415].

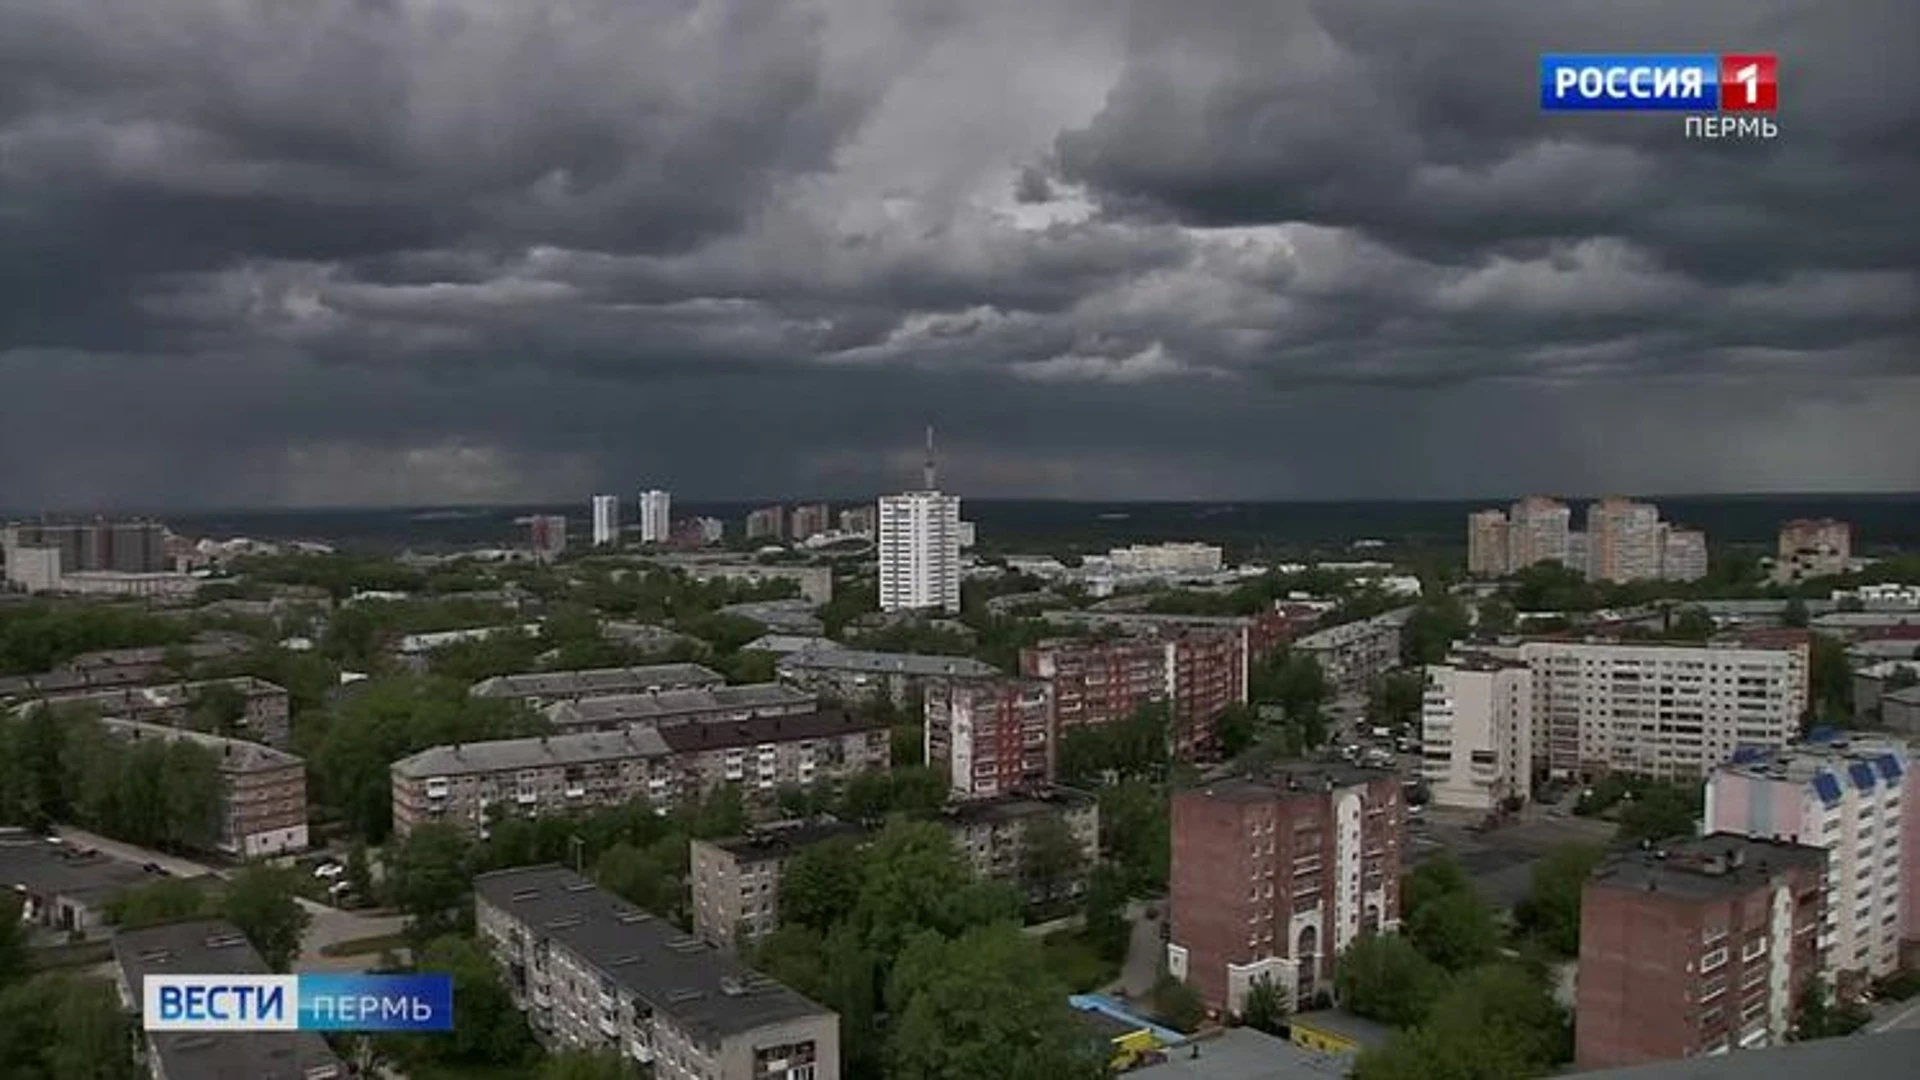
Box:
[1167, 763, 1405, 1013]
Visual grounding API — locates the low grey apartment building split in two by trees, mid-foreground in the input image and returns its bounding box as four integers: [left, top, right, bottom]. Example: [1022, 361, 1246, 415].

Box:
[689, 786, 1100, 949]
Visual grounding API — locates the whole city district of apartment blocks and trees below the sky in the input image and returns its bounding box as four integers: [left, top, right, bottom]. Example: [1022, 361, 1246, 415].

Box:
[0, 480, 1920, 1080]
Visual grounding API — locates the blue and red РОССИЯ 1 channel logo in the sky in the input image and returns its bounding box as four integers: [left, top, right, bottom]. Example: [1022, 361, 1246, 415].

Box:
[1540, 54, 1780, 113]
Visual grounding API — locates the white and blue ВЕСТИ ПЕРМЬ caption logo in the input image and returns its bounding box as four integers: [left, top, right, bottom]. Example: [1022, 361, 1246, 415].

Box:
[140, 974, 453, 1032]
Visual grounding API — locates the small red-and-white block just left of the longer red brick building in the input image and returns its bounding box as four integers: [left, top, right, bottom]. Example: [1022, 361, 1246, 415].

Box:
[922, 678, 1056, 796]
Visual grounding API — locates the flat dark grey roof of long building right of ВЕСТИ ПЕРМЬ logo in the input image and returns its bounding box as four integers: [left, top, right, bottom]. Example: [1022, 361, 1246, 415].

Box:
[474, 865, 835, 1042]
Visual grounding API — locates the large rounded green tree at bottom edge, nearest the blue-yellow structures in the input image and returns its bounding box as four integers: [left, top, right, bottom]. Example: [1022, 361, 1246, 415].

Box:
[887, 926, 1106, 1080]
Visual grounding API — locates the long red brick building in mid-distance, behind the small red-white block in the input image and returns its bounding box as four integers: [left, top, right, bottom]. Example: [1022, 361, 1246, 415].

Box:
[1020, 626, 1246, 757]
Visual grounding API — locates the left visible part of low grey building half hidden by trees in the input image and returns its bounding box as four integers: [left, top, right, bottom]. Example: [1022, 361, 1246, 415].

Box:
[687, 819, 872, 949]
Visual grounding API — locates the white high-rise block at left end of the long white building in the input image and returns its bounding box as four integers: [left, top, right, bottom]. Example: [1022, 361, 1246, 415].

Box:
[1421, 653, 1534, 811]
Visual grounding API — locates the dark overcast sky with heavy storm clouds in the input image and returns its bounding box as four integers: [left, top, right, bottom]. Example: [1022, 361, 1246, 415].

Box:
[0, 0, 1920, 507]
